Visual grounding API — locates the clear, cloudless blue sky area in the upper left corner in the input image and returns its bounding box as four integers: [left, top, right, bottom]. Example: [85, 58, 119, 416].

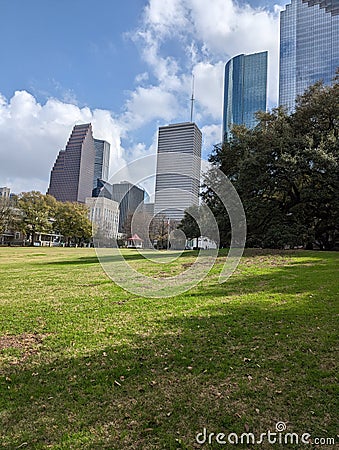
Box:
[0, 0, 146, 110]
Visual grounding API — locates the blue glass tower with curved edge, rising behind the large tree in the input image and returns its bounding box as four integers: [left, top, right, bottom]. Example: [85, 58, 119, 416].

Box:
[222, 52, 267, 140]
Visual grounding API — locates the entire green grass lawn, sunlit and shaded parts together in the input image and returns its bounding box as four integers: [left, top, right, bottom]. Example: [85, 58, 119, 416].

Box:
[0, 247, 339, 450]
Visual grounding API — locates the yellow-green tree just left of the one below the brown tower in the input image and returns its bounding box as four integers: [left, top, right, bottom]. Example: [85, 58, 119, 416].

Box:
[18, 191, 54, 245]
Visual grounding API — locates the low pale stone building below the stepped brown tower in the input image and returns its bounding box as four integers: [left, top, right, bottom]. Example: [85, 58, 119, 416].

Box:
[85, 197, 119, 239]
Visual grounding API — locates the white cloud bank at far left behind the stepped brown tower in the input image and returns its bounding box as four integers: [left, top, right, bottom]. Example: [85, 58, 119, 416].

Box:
[0, 91, 125, 192]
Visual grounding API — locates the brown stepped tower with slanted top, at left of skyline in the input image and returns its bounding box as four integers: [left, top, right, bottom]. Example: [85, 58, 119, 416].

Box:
[47, 123, 95, 203]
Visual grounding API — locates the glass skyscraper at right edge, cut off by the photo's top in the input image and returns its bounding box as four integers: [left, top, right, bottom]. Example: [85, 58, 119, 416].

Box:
[279, 0, 339, 111]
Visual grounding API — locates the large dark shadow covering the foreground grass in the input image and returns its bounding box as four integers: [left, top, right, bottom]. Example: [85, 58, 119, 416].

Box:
[0, 284, 336, 450]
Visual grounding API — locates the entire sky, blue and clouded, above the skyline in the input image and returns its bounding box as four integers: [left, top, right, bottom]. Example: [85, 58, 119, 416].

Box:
[0, 0, 288, 197]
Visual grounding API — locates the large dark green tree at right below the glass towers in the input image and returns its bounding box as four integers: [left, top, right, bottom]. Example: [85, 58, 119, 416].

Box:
[203, 79, 339, 249]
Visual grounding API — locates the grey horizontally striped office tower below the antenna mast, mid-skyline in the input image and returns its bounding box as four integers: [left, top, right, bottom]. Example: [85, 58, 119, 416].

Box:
[154, 122, 202, 221]
